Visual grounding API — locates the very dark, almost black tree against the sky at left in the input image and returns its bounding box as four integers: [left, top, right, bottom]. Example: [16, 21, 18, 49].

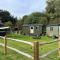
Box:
[0, 10, 17, 25]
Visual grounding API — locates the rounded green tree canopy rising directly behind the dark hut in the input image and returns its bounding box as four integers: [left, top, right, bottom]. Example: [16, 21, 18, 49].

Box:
[24, 12, 45, 24]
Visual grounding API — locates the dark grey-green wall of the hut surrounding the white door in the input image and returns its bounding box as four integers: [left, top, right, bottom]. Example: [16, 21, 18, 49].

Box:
[22, 25, 42, 35]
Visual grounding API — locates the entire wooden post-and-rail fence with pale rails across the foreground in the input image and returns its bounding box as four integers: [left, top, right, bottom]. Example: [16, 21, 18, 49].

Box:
[0, 36, 60, 60]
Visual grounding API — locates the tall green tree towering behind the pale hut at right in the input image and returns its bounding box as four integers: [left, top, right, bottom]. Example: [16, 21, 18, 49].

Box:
[46, 0, 60, 24]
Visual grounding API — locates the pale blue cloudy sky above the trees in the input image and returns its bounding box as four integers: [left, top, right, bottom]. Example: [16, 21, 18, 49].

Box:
[0, 0, 46, 18]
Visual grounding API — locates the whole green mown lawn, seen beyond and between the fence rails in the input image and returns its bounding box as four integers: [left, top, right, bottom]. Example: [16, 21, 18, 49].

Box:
[0, 34, 58, 60]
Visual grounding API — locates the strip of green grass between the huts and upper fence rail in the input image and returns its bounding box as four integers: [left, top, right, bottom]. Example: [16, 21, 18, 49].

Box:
[8, 34, 53, 42]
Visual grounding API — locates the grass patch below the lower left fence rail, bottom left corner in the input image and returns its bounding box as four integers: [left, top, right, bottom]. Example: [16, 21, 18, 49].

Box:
[0, 46, 31, 60]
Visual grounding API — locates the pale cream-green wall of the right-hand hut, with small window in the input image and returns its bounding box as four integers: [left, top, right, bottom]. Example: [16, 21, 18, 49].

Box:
[46, 26, 59, 37]
